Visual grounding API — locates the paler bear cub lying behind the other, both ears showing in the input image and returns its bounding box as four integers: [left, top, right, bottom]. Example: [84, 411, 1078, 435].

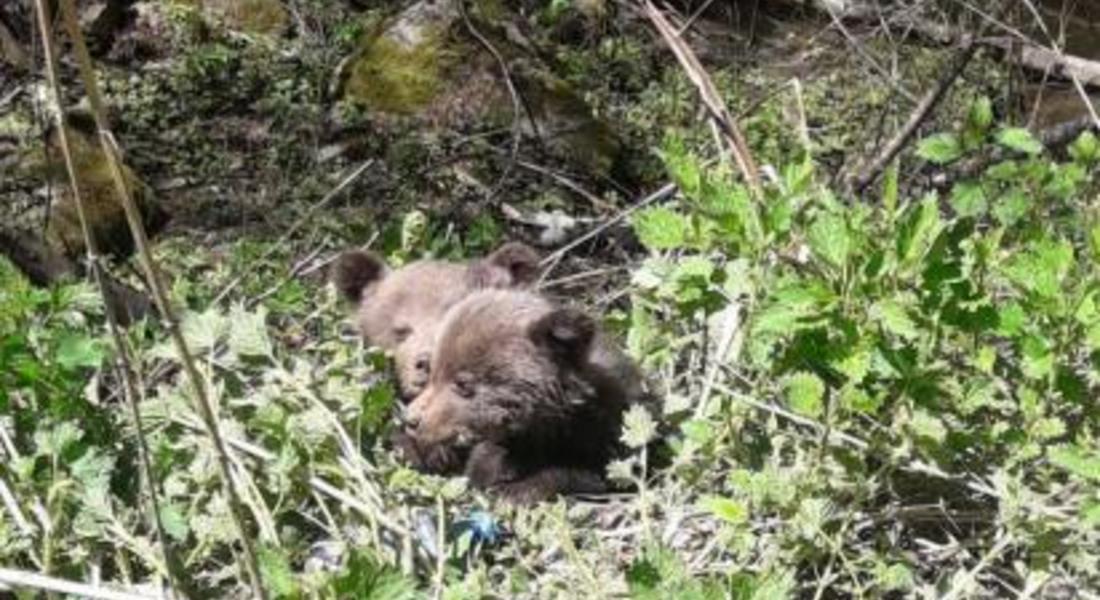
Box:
[331, 242, 539, 401]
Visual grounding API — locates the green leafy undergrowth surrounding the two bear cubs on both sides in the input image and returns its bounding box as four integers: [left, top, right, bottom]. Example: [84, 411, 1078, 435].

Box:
[0, 90, 1100, 599]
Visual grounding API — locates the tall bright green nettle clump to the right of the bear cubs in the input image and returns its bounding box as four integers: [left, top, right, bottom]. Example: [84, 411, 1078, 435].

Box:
[628, 112, 1100, 592]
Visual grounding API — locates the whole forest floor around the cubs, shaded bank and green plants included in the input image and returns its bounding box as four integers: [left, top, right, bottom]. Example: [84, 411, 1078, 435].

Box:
[0, 0, 1100, 598]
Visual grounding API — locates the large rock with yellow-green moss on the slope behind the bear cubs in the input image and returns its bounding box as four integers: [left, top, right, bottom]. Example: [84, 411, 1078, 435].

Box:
[340, 0, 620, 175]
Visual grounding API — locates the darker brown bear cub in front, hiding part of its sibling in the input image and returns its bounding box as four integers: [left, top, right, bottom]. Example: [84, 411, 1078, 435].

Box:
[399, 290, 642, 503]
